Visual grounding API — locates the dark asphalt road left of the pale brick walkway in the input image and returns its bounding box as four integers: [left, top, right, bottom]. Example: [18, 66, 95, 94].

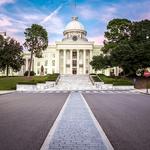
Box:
[0, 93, 68, 150]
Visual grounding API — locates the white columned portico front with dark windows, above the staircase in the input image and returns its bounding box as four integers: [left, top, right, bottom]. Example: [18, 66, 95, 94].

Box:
[59, 49, 92, 74]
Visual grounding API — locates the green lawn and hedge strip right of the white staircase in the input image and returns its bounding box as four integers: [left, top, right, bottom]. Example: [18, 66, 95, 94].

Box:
[98, 74, 133, 86]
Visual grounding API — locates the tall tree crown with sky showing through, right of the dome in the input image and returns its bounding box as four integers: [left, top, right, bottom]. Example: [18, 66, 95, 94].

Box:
[102, 19, 132, 53]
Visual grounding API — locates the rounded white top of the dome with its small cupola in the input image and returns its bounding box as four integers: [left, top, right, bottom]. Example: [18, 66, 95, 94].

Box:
[65, 17, 85, 31]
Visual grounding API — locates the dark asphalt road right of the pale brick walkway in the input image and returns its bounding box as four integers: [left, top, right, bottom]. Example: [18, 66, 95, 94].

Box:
[84, 94, 150, 150]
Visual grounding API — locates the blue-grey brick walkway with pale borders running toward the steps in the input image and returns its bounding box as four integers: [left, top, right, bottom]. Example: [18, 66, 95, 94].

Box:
[41, 92, 113, 150]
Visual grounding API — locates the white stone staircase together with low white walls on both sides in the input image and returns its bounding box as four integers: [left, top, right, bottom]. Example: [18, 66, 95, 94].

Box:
[17, 75, 134, 91]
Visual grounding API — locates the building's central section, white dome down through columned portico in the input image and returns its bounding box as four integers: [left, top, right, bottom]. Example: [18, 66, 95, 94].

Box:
[56, 17, 94, 74]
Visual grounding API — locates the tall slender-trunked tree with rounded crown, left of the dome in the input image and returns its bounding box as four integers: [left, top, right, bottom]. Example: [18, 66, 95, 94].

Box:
[24, 24, 48, 77]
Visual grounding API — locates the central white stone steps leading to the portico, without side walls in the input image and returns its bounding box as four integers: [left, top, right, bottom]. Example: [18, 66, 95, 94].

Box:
[48, 75, 96, 90]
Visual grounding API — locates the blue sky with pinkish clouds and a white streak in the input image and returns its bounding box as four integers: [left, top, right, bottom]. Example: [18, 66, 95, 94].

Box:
[0, 0, 150, 44]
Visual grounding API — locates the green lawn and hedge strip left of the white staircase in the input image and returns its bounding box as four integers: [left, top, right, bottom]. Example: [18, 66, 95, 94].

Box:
[0, 74, 59, 90]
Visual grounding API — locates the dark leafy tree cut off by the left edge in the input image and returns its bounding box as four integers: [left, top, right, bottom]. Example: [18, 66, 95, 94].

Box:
[0, 36, 24, 76]
